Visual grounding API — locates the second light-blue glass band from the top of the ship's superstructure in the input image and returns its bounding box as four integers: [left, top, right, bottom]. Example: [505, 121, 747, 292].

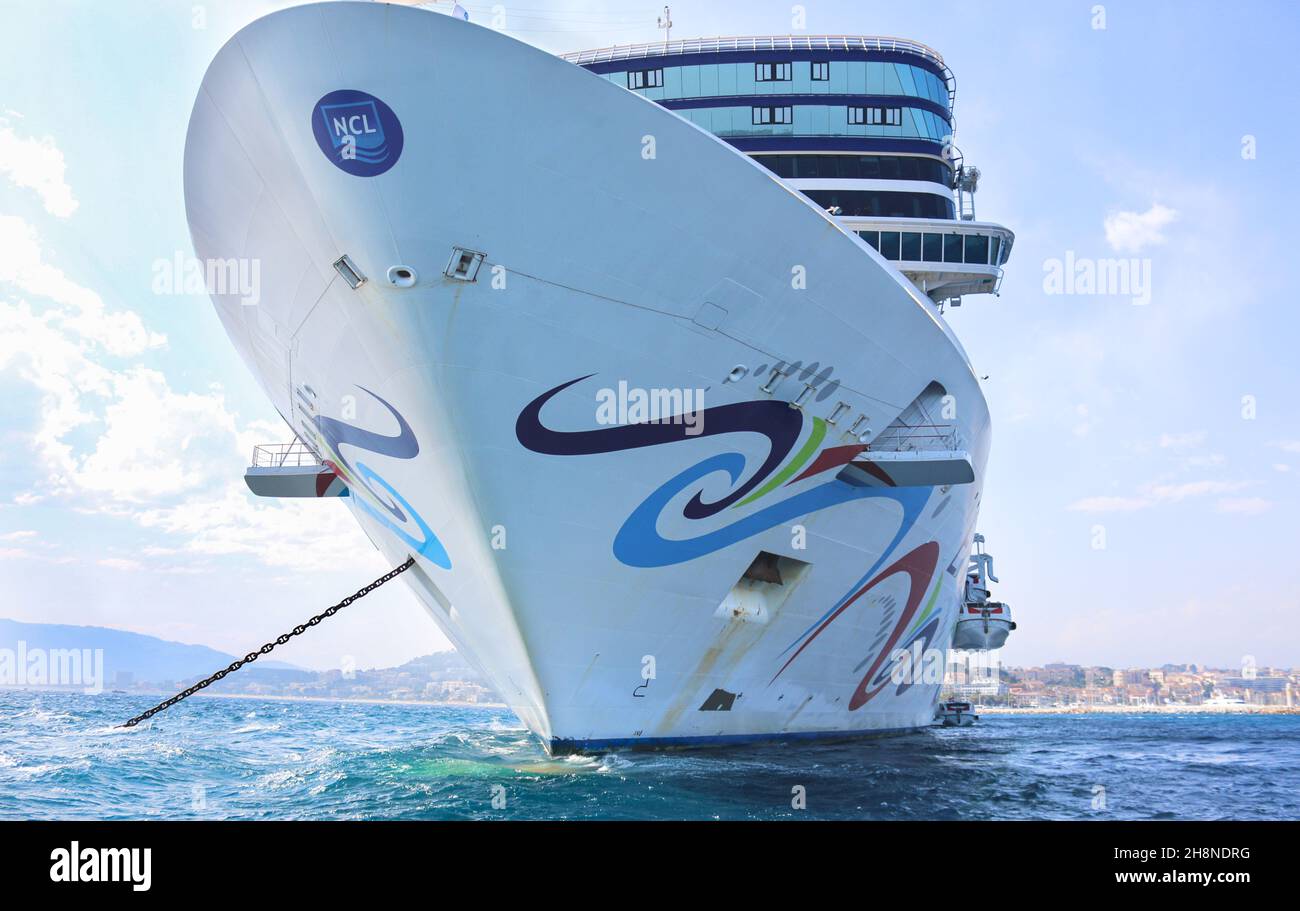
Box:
[673, 104, 953, 143]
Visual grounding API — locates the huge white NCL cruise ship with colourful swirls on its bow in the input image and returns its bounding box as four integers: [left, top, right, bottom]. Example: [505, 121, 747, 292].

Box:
[185, 3, 1013, 754]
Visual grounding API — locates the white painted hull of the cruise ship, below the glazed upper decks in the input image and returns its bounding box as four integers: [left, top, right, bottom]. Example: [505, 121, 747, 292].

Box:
[185, 3, 989, 751]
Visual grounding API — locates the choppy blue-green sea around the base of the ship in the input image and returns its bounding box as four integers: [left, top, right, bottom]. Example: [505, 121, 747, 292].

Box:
[0, 690, 1300, 820]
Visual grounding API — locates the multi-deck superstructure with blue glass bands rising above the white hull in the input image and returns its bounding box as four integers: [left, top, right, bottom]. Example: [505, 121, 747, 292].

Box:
[566, 35, 1015, 305]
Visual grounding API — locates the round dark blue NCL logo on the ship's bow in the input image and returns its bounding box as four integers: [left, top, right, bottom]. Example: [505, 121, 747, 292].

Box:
[312, 88, 402, 177]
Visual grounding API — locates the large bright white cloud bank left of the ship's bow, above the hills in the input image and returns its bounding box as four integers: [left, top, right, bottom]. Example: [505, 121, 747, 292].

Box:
[0, 216, 361, 572]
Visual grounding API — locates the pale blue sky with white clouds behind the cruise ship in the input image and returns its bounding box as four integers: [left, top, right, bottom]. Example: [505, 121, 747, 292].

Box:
[0, 0, 1300, 668]
